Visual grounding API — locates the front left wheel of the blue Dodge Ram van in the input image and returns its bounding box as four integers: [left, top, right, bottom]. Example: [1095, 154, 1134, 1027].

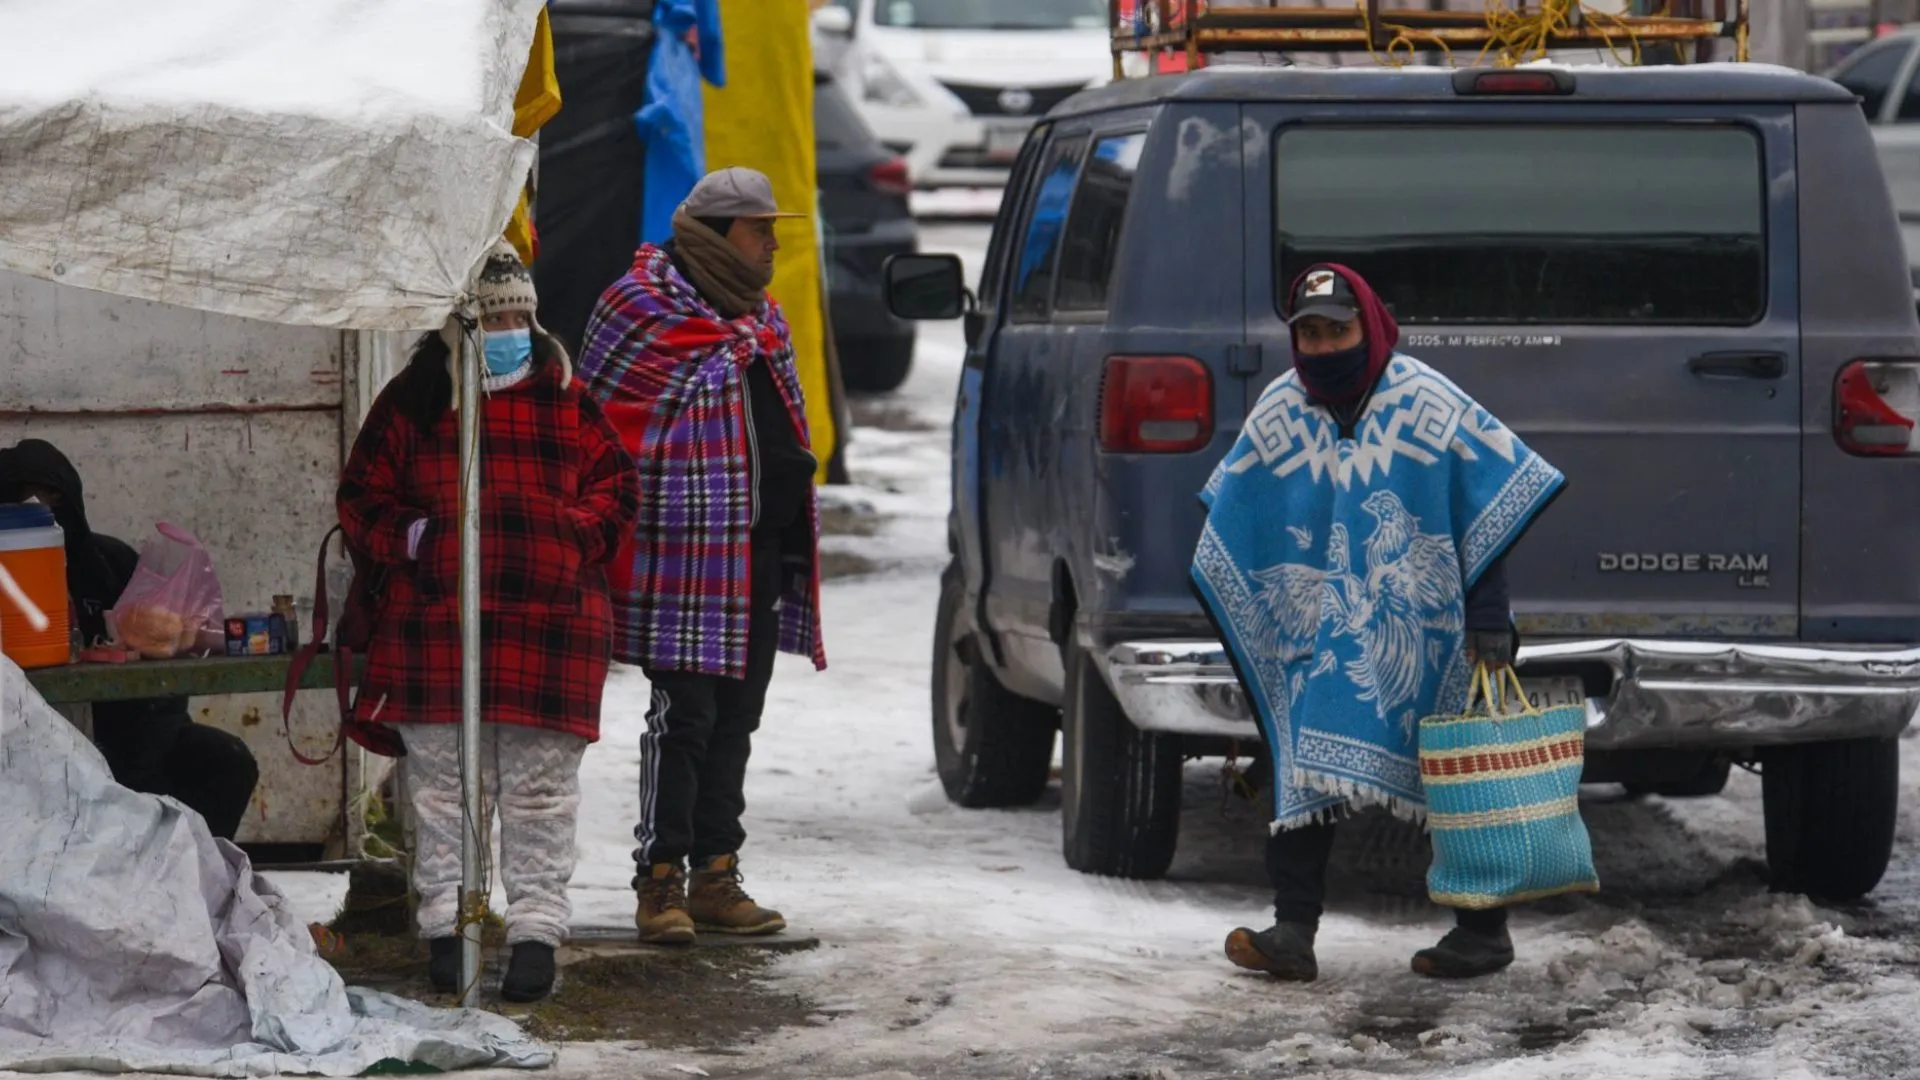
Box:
[933, 565, 1060, 807]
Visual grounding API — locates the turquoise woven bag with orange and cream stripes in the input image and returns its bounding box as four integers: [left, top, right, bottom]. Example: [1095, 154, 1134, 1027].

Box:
[1421, 669, 1599, 911]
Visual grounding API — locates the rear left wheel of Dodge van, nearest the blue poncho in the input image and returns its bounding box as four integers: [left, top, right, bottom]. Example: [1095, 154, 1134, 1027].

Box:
[1060, 646, 1181, 878]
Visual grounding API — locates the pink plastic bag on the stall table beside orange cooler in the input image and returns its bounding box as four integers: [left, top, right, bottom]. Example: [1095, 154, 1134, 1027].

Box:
[108, 521, 227, 659]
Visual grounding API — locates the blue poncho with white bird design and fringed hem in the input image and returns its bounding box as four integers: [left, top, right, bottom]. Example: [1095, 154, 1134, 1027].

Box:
[1192, 354, 1565, 830]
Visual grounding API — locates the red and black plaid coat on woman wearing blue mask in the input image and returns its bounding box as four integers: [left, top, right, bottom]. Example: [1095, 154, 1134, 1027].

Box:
[338, 363, 639, 749]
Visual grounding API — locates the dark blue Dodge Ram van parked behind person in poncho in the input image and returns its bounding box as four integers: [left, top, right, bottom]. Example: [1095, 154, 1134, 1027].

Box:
[889, 65, 1920, 899]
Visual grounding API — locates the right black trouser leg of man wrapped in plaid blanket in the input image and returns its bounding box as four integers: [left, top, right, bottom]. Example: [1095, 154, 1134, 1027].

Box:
[691, 536, 785, 865]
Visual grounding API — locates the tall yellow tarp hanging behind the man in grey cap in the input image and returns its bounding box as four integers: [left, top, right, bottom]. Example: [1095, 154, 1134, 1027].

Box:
[705, 0, 839, 480]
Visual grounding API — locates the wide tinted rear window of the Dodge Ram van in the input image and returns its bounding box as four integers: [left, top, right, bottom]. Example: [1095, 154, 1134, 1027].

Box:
[1275, 125, 1766, 325]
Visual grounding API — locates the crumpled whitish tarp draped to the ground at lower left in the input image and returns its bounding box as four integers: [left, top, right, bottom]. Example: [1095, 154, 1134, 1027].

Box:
[0, 657, 553, 1076]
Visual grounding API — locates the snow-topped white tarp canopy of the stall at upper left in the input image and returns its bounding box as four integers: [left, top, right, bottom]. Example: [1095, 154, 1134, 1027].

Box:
[0, 0, 541, 331]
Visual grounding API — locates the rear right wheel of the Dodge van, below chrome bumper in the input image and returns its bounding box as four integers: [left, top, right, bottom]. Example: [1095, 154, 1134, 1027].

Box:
[1761, 738, 1901, 901]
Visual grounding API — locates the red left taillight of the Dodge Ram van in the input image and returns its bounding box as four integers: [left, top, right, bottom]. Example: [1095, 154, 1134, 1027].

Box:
[1100, 356, 1213, 454]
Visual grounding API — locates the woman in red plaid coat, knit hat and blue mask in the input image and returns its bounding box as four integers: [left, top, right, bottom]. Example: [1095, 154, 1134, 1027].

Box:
[338, 244, 639, 1001]
